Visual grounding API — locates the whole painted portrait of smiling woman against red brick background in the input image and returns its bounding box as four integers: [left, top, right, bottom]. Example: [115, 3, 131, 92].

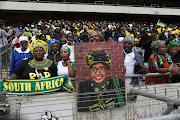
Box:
[75, 42, 126, 112]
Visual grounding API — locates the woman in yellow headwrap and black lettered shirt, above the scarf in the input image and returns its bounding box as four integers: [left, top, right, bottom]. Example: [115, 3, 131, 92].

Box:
[9, 40, 57, 79]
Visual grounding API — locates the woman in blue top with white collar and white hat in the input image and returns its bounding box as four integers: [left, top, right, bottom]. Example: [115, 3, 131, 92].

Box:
[9, 36, 34, 75]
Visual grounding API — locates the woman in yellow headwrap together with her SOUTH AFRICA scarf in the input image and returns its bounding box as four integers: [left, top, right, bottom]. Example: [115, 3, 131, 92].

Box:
[0, 40, 75, 94]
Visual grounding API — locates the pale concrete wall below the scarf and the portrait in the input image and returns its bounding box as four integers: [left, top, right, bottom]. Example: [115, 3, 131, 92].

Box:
[3, 83, 180, 120]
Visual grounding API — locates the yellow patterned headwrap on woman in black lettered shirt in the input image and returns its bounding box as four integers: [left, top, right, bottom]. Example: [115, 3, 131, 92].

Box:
[29, 40, 48, 53]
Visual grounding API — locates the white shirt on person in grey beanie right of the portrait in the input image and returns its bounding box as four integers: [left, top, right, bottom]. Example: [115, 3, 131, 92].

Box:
[124, 51, 136, 87]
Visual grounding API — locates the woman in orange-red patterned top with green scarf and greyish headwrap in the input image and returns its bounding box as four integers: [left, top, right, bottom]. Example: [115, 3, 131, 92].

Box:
[146, 40, 180, 84]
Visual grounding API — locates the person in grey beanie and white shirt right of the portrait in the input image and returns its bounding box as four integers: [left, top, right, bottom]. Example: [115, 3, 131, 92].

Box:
[122, 36, 146, 87]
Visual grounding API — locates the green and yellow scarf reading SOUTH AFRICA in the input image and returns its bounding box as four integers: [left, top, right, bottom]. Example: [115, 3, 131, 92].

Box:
[0, 75, 75, 94]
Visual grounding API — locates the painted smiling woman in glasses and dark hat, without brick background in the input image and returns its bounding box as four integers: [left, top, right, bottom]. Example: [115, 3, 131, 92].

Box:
[77, 49, 126, 112]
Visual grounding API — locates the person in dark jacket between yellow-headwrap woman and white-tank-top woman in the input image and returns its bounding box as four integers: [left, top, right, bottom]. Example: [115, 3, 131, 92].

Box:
[47, 42, 62, 64]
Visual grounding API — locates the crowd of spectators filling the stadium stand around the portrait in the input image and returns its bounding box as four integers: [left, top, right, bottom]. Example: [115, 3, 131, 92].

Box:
[0, 19, 180, 87]
